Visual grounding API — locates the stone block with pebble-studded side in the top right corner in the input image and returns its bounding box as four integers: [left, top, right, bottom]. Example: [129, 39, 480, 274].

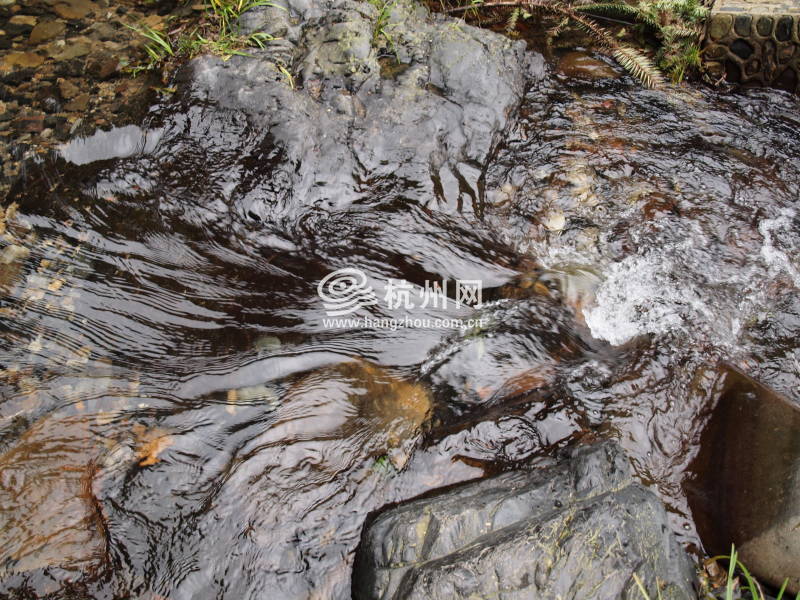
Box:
[705, 0, 800, 92]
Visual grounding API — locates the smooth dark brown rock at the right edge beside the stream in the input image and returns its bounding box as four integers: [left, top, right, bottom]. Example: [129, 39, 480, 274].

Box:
[685, 368, 800, 595]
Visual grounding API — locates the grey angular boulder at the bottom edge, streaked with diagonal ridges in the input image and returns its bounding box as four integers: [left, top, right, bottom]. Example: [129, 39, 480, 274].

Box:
[353, 443, 696, 600]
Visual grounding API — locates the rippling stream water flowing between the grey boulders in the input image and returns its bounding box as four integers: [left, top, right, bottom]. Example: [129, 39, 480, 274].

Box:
[0, 54, 800, 599]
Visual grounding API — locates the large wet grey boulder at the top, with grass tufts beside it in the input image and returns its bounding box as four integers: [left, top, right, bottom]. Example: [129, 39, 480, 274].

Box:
[128, 0, 544, 241]
